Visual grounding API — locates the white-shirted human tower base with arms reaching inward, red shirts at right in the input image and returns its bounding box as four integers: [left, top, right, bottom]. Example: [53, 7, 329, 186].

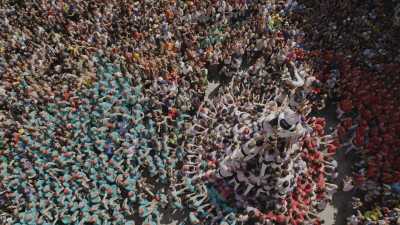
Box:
[178, 77, 337, 222]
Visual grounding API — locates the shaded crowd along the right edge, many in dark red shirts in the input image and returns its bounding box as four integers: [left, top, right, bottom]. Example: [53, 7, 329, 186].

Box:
[305, 1, 400, 225]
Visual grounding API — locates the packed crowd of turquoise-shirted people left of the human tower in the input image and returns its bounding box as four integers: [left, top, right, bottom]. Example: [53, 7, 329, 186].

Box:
[0, 55, 191, 224]
